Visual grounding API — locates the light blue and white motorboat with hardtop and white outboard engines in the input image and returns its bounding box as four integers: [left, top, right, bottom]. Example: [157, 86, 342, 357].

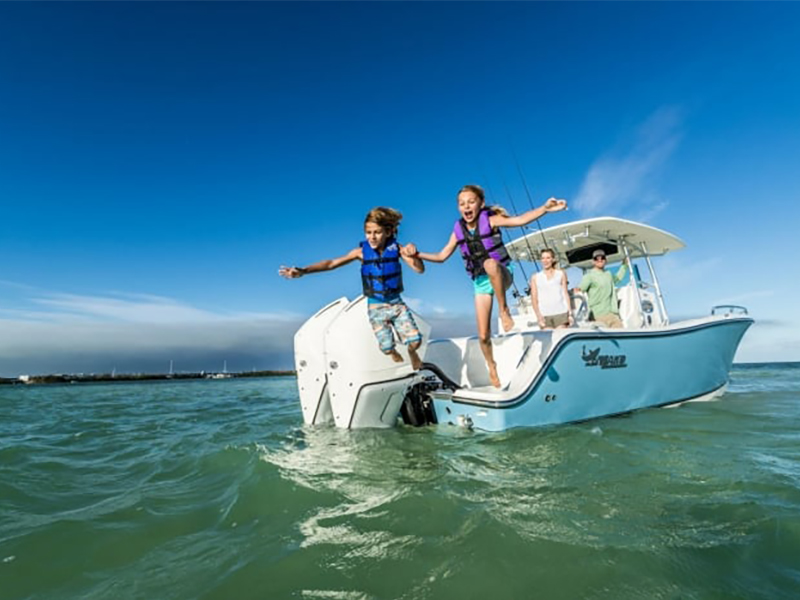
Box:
[295, 217, 753, 431]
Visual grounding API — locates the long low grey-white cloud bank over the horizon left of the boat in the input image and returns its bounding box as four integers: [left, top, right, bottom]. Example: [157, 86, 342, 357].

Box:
[0, 288, 303, 376]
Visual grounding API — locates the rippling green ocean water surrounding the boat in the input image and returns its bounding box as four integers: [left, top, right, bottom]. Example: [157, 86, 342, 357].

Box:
[0, 364, 800, 600]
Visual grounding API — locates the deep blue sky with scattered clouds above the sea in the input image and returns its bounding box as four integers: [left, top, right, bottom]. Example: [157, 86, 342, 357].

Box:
[0, 2, 800, 376]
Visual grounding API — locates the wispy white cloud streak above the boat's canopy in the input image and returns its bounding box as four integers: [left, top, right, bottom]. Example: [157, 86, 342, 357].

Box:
[574, 107, 683, 218]
